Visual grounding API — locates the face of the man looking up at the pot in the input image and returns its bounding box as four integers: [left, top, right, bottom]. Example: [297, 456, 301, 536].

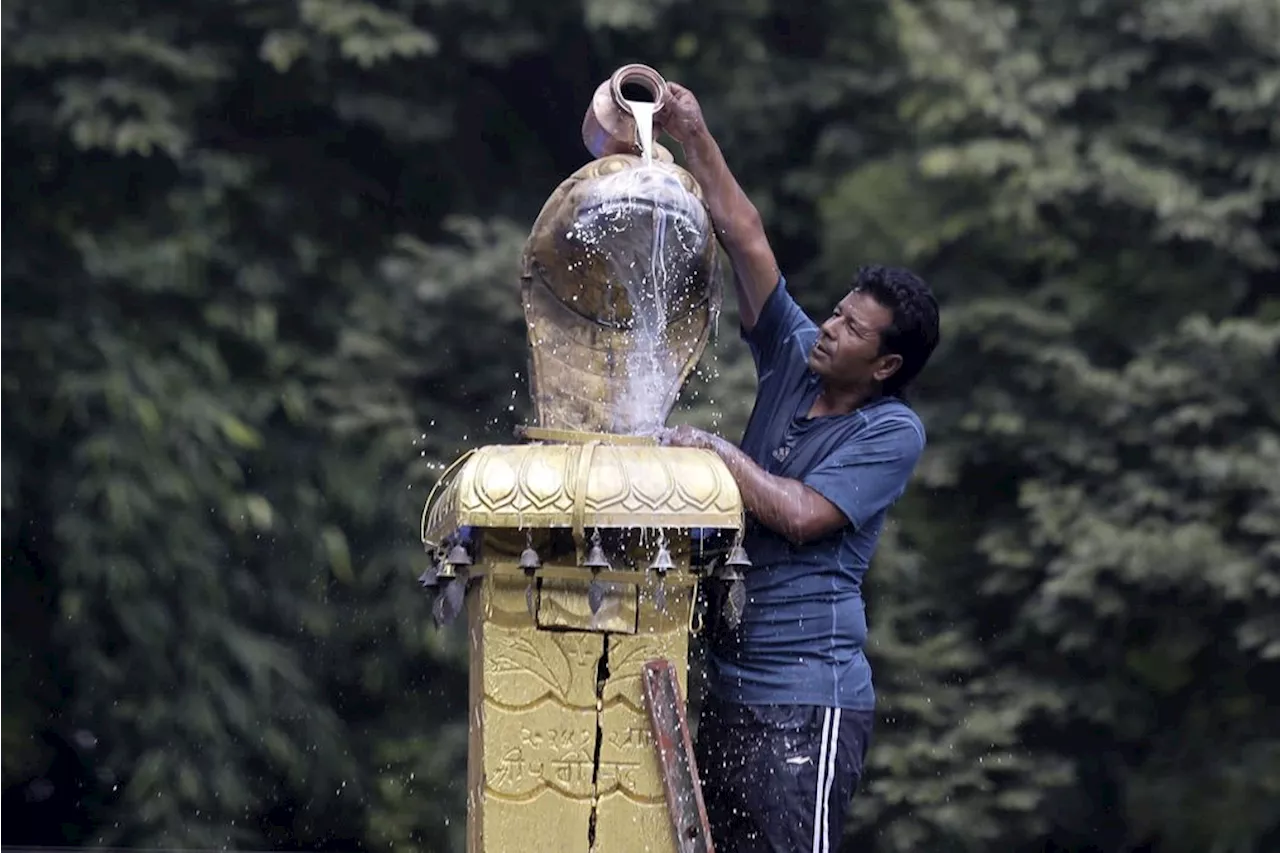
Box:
[809, 291, 902, 388]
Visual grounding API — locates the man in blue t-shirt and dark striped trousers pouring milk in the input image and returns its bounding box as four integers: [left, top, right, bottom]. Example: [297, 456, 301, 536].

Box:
[658, 83, 938, 853]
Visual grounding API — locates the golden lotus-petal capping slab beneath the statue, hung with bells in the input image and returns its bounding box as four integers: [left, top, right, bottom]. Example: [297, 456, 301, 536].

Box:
[422, 443, 742, 542]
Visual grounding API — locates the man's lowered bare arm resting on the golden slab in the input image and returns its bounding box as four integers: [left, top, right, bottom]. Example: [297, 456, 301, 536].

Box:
[663, 427, 849, 544]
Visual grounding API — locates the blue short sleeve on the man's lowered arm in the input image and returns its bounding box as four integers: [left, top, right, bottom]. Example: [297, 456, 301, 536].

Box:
[803, 410, 924, 529]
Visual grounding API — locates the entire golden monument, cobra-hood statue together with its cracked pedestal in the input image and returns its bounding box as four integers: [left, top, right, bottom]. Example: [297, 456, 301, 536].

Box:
[422, 63, 742, 853]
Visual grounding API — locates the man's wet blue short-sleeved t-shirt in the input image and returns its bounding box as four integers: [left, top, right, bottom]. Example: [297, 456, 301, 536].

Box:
[708, 279, 924, 710]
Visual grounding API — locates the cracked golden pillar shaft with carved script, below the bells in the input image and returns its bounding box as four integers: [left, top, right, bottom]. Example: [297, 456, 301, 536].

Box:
[467, 563, 694, 853]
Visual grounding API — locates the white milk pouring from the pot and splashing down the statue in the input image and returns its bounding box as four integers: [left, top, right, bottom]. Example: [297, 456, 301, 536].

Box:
[568, 101, 709, 434]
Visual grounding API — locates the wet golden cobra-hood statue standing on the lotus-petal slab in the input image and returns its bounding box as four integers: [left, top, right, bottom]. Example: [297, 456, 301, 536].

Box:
[521, 151, 722, 434]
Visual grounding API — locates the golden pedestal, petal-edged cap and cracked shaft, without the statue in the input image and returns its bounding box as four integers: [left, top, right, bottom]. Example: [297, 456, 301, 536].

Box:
[424, 444, 741, 853]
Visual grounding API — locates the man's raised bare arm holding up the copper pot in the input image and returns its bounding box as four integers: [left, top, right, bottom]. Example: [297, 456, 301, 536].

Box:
[657, 83, 780, 332]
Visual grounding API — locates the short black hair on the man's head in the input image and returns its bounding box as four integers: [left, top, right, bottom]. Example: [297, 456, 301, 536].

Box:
[852, 266, 938, 397]
